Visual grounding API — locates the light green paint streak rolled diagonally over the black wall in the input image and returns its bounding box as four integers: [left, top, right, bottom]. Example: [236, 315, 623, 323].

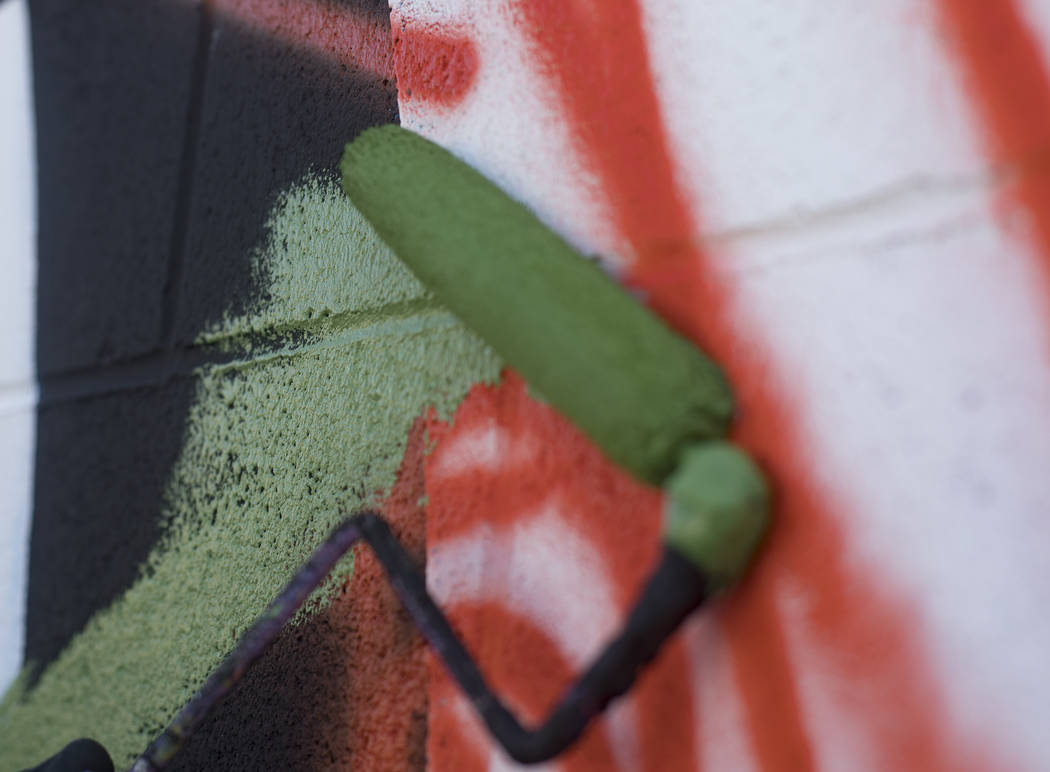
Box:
[0, 173, 500, 769]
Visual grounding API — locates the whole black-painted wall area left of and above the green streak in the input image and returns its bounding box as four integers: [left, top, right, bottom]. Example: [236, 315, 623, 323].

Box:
[26, 0, 397, 672]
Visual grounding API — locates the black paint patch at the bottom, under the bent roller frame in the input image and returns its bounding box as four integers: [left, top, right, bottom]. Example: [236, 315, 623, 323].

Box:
[168, 614, 356, 772]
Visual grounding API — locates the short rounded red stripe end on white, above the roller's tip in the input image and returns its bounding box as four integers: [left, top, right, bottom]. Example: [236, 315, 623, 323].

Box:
[391, 13, 478, 105]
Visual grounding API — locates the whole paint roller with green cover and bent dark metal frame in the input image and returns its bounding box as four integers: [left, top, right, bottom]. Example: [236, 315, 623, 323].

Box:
[28, 126, 770, 772]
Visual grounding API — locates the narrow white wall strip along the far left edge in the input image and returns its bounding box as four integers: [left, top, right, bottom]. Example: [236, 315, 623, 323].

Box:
[0, 0, 37, 691]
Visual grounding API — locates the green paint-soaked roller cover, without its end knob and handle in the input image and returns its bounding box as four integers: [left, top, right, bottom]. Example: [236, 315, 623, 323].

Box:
[342, 126, 732, 484]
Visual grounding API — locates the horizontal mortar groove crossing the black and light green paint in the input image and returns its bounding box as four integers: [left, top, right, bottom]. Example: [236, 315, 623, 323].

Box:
[39, 298, 458, 406]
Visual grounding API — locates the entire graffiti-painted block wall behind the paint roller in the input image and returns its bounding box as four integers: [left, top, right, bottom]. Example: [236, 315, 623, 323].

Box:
[0, 0, 1050, 772]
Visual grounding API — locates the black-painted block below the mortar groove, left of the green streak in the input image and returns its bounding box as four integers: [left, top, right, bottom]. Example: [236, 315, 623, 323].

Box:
[26, 377, 193, 664]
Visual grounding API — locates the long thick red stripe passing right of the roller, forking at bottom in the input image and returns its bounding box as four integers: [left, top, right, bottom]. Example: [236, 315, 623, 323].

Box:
[512, 0, 995, 770]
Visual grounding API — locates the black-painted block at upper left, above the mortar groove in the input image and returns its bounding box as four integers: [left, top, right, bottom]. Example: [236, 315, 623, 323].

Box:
[29, 0, 196, 378]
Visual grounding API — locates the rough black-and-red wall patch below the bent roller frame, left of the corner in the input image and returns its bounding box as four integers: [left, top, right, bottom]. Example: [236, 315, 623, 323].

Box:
[165, 420, 426, 772]
